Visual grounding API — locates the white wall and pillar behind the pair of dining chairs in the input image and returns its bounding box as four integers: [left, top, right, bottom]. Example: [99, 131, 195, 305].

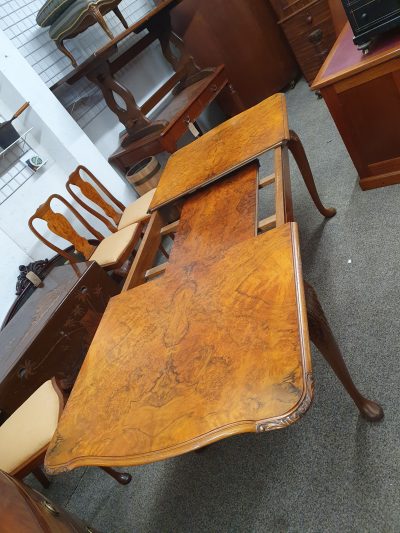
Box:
[0, 31, 135, 320]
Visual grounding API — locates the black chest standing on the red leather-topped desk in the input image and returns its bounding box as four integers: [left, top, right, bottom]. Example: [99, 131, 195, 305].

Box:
[342, 0, 400, 48]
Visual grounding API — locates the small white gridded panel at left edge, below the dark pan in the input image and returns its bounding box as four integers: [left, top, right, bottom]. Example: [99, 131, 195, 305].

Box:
[0, 128, 47, 205]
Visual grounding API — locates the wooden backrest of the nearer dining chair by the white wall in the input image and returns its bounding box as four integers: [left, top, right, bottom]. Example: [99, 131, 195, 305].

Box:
[28, 194, 104, 263]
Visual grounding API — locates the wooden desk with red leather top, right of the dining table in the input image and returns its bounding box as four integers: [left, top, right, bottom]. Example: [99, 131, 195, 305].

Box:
[312, 24, 400, 190]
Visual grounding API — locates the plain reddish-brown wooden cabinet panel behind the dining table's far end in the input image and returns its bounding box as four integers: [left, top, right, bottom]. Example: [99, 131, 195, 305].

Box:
[167, 0, 298, 112]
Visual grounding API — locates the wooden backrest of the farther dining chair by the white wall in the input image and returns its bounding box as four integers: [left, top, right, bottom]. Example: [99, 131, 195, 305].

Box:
[65, 165, 125, 233]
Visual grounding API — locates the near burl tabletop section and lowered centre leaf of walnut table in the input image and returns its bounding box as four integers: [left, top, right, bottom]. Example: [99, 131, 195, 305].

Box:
[46, 165, 312, 472]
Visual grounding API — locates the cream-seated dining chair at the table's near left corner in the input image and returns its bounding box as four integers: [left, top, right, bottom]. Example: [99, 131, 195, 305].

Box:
[0, 378, 132, 488]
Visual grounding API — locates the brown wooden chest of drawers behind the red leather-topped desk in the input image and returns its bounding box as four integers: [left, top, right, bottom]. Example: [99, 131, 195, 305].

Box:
[270, 0, 336, 85]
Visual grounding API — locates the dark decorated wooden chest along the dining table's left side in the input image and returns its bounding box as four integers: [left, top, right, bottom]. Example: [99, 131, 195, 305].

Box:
[0, 262, 119, 421]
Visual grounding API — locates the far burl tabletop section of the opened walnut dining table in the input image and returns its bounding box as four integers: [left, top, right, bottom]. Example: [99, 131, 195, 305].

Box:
[150, 93, 290, 211]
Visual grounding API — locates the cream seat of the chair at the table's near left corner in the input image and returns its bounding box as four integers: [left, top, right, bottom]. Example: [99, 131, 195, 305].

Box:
[0, 380, 63, 474]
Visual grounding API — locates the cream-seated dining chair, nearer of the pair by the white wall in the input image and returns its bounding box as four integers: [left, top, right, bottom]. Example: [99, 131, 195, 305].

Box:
[28, 194, 142, 270]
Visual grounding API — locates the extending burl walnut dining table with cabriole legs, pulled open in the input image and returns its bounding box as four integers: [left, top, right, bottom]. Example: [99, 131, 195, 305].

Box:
[45, 95, 383, 473]
